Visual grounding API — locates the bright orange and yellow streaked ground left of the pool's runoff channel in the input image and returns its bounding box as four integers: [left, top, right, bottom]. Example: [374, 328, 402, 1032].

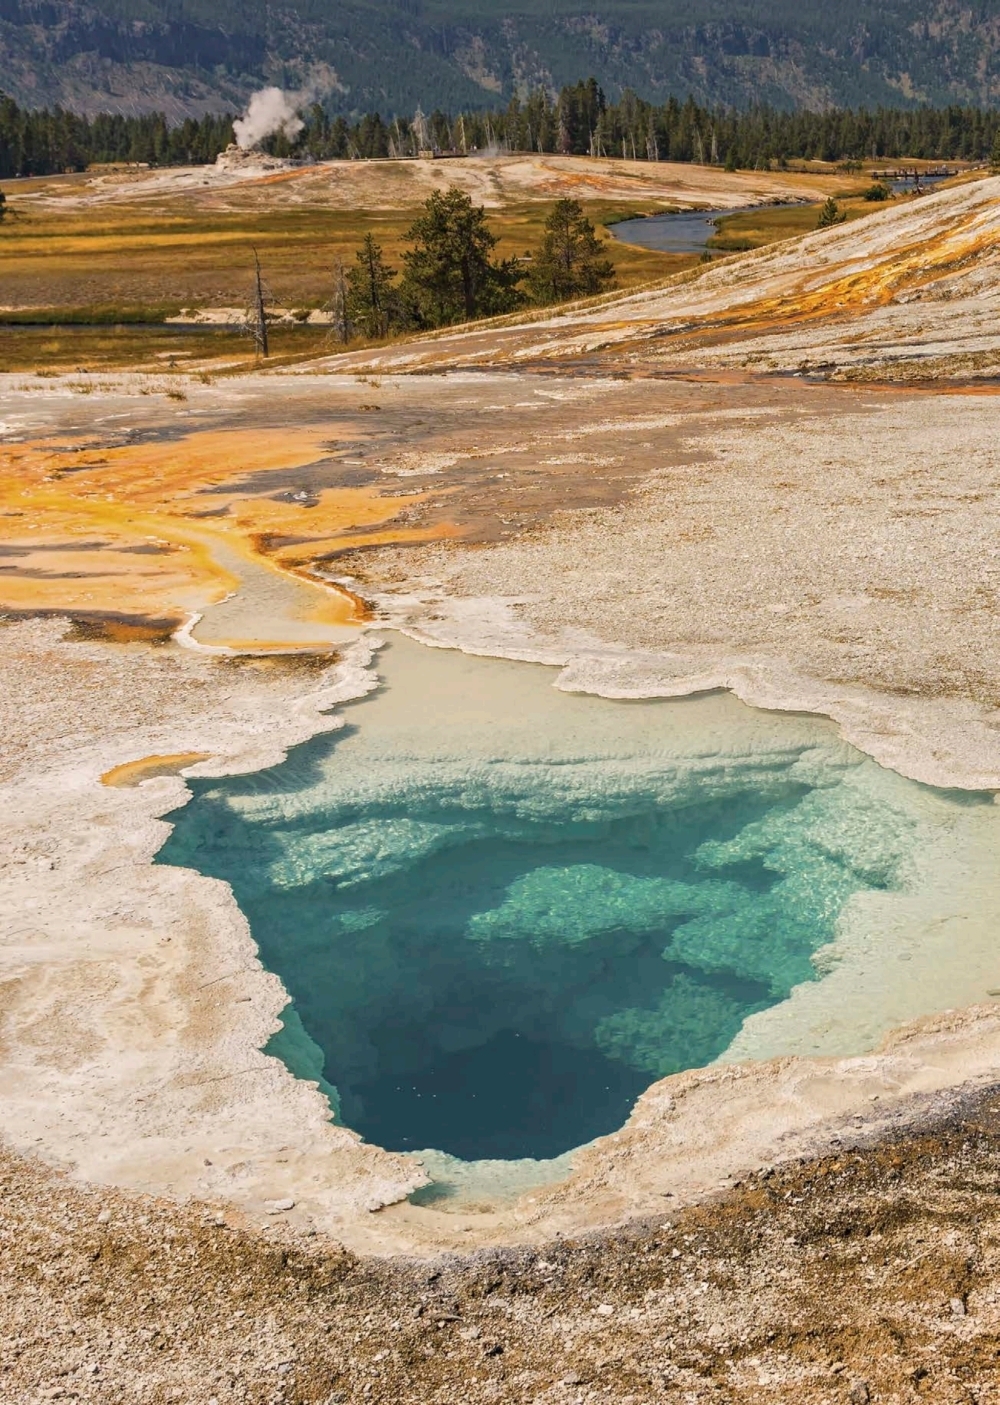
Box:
[0, 424, 451, 646]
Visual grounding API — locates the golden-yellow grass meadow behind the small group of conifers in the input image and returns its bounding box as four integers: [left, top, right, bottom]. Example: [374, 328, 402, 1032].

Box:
[0, 166, 874, 371]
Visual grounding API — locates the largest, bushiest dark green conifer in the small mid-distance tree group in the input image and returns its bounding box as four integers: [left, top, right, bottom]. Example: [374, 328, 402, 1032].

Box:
[400, 185, 522, 327]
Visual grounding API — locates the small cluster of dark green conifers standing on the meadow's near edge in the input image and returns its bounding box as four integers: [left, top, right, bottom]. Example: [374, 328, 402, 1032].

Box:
[330, 185, 615, 341]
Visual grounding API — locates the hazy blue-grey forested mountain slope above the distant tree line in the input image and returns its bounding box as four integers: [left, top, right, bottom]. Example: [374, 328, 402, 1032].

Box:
[0, 0, 1000, 117]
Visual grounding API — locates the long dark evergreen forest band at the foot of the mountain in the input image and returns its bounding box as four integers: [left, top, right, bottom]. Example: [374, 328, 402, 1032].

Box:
[0, 79, 1000, 178]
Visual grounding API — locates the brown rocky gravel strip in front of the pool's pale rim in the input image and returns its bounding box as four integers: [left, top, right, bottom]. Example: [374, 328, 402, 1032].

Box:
[0, 1087, 1000, 1405]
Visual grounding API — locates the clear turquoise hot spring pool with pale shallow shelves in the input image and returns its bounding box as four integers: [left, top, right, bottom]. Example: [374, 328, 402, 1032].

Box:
[159, 638, 1000, 1162]
